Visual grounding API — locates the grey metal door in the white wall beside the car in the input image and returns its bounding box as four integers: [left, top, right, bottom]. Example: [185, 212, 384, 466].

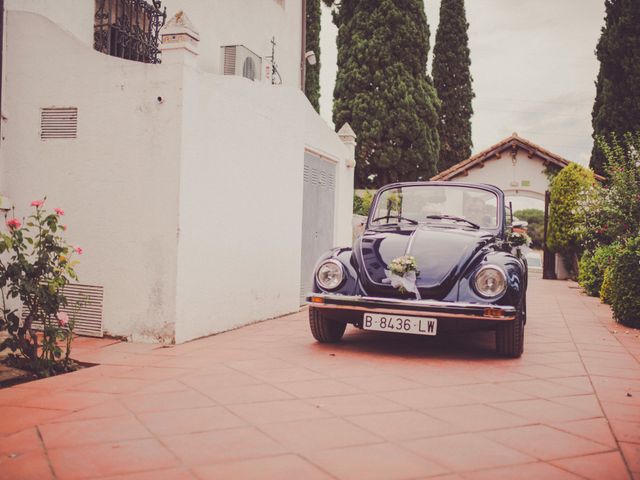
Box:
[300, 152, 336, 304]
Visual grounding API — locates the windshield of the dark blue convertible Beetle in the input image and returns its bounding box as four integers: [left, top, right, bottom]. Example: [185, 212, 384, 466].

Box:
[370, 185, 498, 228]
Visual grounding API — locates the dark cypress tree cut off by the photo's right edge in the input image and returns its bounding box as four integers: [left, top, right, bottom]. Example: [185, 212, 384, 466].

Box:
[589, 0, 640, 175]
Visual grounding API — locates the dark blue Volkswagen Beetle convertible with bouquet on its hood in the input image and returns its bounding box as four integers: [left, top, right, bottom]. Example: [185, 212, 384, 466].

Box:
[306, 182, 527, 357]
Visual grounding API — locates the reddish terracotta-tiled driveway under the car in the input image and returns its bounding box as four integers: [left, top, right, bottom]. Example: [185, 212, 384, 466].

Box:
[0, 279, 640, 480]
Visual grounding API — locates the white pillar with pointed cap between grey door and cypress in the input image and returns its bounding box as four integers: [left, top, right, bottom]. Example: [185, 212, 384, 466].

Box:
[336, 123, 356, 247]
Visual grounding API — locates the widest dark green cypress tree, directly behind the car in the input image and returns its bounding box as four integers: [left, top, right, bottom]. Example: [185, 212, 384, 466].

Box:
[324, 0, 440, 188]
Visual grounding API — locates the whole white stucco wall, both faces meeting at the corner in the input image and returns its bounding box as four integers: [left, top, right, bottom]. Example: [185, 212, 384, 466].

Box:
[0, 7, 353, 342]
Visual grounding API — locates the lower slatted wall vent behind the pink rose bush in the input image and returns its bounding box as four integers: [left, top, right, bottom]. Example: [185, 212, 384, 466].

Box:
[22, 283, 104, 337]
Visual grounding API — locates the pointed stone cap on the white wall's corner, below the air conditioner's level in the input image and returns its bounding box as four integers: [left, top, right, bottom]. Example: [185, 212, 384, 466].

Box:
[160, 10, 200, 66]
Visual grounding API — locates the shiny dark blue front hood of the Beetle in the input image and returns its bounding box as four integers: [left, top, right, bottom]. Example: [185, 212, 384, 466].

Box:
[355, 225, 494, 299]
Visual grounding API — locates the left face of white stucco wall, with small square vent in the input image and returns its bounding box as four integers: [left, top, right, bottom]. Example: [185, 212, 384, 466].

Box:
[0, 10, 181, 340]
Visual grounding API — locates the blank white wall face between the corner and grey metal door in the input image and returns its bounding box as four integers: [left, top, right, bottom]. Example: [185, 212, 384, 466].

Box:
[176, 69, 306, 342]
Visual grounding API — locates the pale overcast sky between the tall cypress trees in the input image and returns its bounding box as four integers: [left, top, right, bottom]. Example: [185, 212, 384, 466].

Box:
[320, 0, 604, 165]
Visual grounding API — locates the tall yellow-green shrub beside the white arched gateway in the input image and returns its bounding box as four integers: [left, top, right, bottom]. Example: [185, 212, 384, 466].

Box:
[547, 163, 596, 258]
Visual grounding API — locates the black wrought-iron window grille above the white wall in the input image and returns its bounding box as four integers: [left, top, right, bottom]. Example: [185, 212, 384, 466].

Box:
[93, 0, 167, 63]
